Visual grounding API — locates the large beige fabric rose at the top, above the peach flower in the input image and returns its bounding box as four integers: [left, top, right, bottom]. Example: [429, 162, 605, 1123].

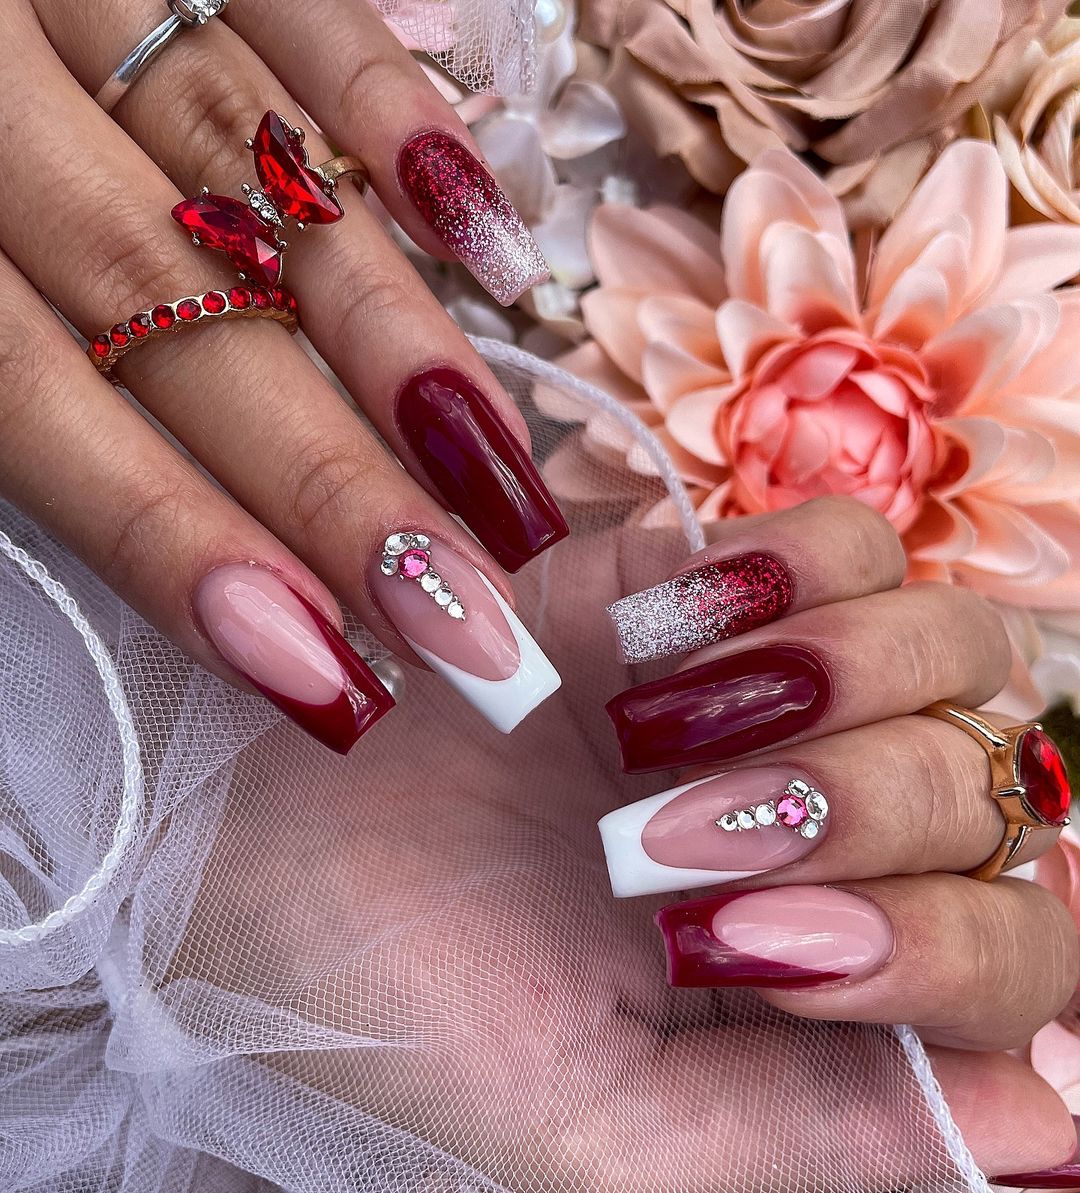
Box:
[580, 0, 1066, 223]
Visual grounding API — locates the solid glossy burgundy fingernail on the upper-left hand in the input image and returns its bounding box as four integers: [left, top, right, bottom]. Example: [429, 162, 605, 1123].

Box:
[396, 369, 569, 571]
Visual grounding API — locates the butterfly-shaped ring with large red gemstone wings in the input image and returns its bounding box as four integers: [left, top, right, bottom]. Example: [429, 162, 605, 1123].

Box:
[173, 112, 368, 286]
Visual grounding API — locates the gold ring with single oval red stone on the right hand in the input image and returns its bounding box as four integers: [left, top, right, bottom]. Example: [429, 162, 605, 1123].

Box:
[921, 700, 1072, 883]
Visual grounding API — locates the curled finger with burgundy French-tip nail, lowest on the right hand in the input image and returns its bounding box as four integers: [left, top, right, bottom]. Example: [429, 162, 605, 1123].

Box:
[658, 874, 1080, 1049]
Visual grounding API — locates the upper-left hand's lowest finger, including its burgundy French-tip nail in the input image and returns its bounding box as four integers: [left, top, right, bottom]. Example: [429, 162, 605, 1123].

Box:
[0, 245, 394, 753]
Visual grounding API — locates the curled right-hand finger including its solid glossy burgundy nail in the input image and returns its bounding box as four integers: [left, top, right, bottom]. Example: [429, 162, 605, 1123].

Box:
[607, 585, 1011, 773]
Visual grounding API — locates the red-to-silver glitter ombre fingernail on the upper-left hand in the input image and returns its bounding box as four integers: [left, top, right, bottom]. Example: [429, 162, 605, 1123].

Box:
[397, 129, 550, 307]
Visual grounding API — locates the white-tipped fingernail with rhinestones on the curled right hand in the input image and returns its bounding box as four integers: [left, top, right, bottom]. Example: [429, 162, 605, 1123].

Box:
[599, 766, 829, 898]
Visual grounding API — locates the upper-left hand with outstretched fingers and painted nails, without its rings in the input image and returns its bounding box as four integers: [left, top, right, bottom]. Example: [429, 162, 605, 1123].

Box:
[0, 0, 566, 750]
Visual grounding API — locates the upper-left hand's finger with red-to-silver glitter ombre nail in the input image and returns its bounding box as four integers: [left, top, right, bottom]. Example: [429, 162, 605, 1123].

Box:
[227, 0, 548, 304]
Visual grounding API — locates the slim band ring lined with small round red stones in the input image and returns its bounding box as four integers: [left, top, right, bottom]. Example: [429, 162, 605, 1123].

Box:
[86, 285, 300, 384]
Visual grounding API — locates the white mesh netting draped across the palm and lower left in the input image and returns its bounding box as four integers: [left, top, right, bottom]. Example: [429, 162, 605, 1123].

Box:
[0, 345, 980, 1193]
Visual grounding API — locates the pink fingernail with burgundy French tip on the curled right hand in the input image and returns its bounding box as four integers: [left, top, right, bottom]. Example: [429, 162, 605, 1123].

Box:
[656, 886, 893, 987]
